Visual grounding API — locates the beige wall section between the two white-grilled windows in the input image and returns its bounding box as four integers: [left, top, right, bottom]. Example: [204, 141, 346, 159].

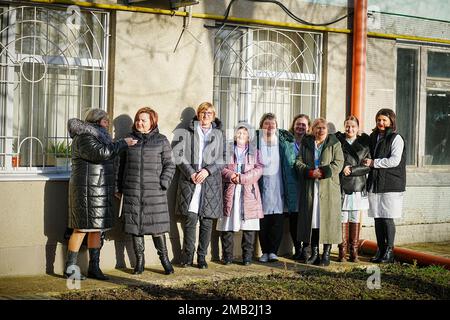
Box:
[112, 8, 213, 138]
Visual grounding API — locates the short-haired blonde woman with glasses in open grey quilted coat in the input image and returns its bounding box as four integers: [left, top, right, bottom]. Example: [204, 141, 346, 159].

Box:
[173, 102, 225, 269]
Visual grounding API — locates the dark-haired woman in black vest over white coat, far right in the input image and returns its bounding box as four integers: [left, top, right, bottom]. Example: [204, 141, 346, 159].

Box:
[364, 109, 406, 263]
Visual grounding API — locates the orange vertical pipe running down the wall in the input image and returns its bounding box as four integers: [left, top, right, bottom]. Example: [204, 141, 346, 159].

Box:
[350, 0, 367, 126]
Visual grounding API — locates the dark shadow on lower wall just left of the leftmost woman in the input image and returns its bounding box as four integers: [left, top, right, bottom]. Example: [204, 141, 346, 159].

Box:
[44, 181, 87, 274]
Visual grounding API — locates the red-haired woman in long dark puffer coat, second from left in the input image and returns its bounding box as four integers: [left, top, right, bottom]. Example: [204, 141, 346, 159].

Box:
[117, 107, 175, 274]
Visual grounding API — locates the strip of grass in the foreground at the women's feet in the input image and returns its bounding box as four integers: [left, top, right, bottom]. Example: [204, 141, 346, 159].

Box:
[60, 263, 450, 300]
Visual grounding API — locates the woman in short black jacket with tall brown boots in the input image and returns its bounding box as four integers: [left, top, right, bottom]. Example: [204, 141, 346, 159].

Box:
[336, 116, 370, 262]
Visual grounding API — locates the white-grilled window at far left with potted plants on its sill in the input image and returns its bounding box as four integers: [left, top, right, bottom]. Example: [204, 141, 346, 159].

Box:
[0, 6, 108, 179]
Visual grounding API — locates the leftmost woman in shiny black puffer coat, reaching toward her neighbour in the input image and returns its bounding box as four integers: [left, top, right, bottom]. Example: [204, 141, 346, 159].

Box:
[64, 109, 136, 280]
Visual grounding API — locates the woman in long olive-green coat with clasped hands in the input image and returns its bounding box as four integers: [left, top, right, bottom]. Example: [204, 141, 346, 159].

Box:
[296, 118, 344, 266]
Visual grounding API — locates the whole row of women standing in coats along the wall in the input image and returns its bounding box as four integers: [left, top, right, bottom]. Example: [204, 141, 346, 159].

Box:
[64, 102, 406, 280]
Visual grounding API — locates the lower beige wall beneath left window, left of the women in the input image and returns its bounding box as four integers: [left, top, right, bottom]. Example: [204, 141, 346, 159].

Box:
[0, 181, 67, 275]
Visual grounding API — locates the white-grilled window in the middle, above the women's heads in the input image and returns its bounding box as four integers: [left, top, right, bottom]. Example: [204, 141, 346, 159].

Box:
[214, 25, 322, 129]
